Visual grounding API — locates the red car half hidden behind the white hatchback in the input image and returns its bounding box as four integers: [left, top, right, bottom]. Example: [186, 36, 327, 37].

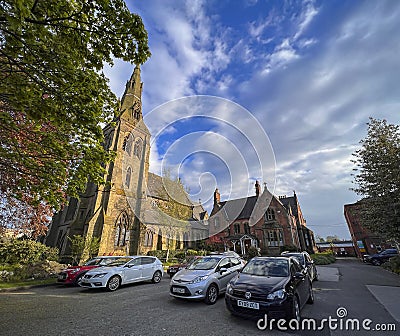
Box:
[57, 256, 121, 285]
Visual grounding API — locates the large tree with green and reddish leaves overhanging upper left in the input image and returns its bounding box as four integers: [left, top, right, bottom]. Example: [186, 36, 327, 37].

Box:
[0, 0, 150, 234]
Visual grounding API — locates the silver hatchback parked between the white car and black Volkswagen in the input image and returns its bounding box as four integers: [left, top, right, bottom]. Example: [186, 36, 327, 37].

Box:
[170, 254, 245, 305]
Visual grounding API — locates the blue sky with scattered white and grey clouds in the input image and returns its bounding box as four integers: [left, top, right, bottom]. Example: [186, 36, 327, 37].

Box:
[105, 0, 400, 239]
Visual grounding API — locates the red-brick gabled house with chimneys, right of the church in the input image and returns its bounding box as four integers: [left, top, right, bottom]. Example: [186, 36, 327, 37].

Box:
[209, 181, 316, 255]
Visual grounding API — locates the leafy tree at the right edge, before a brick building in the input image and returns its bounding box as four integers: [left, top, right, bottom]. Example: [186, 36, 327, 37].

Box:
[353, 118, 400, 242]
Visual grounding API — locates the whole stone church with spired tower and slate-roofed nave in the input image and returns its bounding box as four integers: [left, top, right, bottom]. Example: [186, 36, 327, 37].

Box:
[45, 66, 208, 257]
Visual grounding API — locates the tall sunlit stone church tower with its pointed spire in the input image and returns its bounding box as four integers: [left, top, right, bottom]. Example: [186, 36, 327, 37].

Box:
[85, 66, 150, 255]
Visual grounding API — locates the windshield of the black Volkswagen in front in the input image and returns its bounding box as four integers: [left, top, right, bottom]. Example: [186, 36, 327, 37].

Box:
[242, 259, 289, 277]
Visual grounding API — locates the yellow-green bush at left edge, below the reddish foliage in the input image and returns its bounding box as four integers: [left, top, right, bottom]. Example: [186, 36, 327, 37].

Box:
[0, 239, 58, 264]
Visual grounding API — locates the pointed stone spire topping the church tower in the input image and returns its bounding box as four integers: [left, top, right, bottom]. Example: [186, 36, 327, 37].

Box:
[121, 65, 143, 121]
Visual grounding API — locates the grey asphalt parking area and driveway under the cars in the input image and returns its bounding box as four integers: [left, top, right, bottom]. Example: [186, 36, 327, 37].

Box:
[0, 260, 400, 336]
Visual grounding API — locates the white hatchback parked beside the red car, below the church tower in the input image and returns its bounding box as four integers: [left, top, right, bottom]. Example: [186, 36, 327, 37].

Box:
[79, 256, 164, 291]
